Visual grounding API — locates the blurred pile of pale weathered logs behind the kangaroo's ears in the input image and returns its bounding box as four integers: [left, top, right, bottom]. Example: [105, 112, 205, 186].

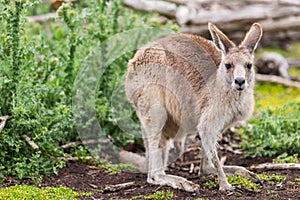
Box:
[125, 0, 300, 45]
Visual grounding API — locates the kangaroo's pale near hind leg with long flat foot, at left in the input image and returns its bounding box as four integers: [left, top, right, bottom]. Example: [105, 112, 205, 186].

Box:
[138, 91, 199, 192]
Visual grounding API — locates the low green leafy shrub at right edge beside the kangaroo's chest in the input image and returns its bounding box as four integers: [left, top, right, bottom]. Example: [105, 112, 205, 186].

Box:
[241, 103, 300, 156]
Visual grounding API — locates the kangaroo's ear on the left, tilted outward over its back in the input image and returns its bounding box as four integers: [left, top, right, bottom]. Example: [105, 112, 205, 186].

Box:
[208, 23, 235, 54]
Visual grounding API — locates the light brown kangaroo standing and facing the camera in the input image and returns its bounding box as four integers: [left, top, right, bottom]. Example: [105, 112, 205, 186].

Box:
[125, 23, 262, 193]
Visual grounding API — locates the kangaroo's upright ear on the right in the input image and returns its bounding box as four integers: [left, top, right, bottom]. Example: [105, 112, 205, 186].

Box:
[240, 23, 262, 53]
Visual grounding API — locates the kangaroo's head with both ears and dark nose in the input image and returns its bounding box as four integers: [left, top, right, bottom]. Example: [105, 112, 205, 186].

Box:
[208, 23, 262, 91]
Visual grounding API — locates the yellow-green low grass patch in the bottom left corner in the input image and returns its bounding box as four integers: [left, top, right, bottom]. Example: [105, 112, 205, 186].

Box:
[0, 185, 93, 200]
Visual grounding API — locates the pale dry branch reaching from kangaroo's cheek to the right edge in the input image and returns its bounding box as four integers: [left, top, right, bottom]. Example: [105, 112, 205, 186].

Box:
[255, 74, 300, 89]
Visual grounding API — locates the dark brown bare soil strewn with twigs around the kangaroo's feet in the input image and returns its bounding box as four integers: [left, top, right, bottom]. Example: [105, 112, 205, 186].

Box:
[0, 134, 300, 200]
